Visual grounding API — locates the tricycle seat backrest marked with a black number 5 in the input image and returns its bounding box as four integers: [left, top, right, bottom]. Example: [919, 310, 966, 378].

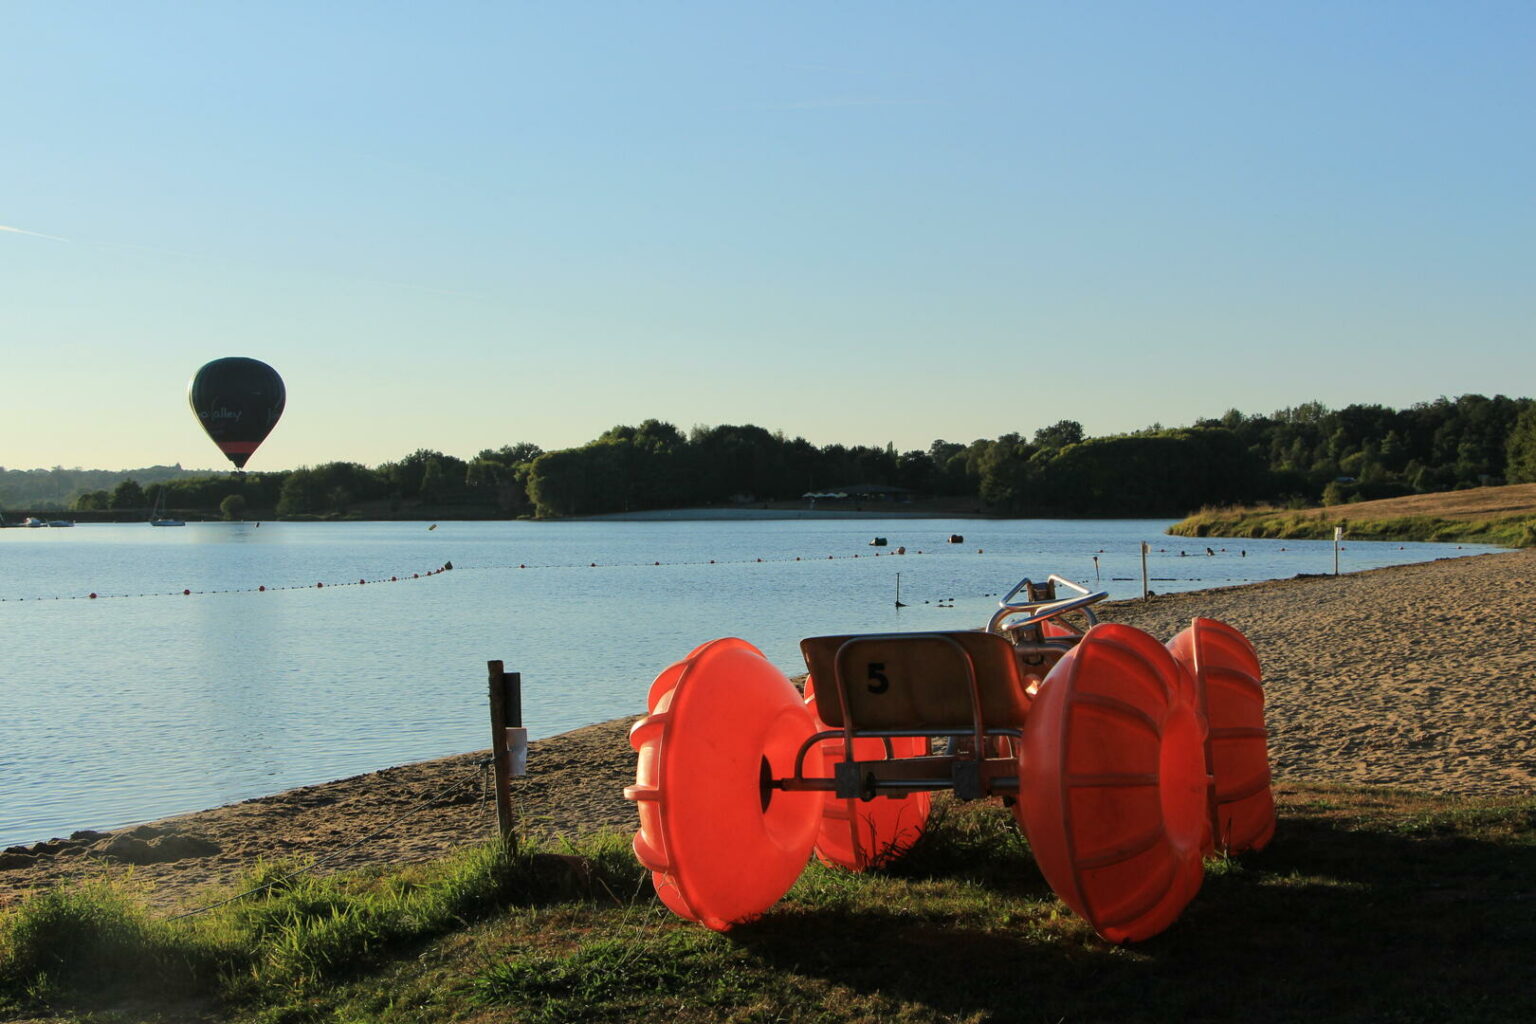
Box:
[800, 631, 1028, 729]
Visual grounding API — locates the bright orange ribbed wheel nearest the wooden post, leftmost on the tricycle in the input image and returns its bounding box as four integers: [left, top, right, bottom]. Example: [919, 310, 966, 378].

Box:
[624, 639, 820, 932]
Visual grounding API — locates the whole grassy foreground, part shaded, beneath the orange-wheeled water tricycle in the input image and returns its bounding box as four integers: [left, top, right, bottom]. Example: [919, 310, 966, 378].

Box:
[0, 786, 1536, 1024]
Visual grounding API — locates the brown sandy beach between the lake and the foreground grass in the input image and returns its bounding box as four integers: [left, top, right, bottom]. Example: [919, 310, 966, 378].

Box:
[0, 550, 1536, 909]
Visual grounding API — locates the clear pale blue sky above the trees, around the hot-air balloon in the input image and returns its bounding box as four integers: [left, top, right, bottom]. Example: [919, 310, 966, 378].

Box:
[0, 0, 1536, 470]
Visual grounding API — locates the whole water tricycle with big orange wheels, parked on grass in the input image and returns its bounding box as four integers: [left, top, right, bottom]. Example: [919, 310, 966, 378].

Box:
[624, 576, 1275, 943]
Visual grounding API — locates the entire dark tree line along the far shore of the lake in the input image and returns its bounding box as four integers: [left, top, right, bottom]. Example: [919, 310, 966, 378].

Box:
[12, 395, 1536, 517]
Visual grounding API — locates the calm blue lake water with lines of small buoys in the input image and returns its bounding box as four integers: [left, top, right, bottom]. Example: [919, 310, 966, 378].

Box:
[0, 519, 1491, 847]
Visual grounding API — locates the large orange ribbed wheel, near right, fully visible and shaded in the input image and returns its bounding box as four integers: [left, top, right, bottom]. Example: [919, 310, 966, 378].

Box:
[1014, 623, 1210, 943]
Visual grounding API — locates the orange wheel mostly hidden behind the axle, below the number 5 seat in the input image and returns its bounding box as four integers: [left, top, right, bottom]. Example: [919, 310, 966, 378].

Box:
[805, 676, 932, 870]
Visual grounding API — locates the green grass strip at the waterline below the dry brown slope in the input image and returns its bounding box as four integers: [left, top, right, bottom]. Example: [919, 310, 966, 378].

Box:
[1167, 505, 1536, 548]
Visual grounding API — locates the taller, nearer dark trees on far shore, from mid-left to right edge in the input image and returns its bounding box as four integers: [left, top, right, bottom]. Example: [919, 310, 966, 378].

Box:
[513, 395, 1536, 516]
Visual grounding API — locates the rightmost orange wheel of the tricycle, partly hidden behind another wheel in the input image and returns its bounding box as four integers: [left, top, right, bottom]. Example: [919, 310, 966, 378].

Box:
[1167, 619, 1275, 854]
